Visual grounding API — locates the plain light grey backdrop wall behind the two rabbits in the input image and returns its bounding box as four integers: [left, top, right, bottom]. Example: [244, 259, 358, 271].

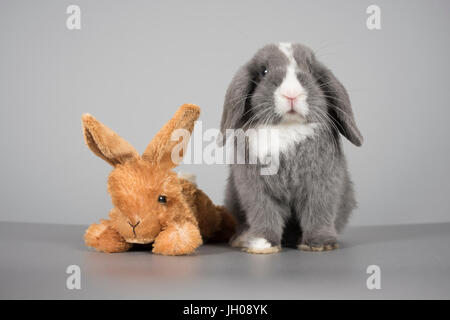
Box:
[0, 0, 450, 225]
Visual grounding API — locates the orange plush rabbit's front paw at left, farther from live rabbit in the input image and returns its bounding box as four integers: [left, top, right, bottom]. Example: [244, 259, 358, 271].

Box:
[84, 221, 132, 253]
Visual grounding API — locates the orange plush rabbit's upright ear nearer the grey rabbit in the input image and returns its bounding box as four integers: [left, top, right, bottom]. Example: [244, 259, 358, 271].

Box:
[142, 104, 200, 168]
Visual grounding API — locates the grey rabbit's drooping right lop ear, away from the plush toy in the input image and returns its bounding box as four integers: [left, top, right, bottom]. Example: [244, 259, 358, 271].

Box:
[313, 59, 363, 147]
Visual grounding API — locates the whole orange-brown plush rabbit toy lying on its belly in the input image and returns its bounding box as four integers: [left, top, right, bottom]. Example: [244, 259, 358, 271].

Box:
[82, 104, 235, 255]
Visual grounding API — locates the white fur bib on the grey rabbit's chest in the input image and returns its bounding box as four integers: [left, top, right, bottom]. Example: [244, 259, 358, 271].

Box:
[249, 122, 318, 163]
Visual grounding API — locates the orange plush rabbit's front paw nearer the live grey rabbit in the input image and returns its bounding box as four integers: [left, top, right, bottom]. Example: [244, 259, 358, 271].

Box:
[152, 223, 203, 256]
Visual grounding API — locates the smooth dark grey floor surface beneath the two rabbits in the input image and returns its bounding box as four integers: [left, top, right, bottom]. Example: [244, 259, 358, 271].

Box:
[0, 222, 450, 299]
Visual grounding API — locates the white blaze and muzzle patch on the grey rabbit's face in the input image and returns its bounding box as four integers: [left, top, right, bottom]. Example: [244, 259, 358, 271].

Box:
[274, 43, 309, 118]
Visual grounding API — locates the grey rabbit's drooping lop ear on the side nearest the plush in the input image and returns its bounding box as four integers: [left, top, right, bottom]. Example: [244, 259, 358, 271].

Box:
[218, 64, 255, 145]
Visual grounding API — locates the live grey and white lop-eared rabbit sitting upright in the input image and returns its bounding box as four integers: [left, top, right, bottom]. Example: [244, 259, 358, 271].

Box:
[221, 43, 363, 253]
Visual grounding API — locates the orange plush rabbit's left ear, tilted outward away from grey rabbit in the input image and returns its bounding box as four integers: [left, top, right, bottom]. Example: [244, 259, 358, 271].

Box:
[81, 113, 139, 166]
